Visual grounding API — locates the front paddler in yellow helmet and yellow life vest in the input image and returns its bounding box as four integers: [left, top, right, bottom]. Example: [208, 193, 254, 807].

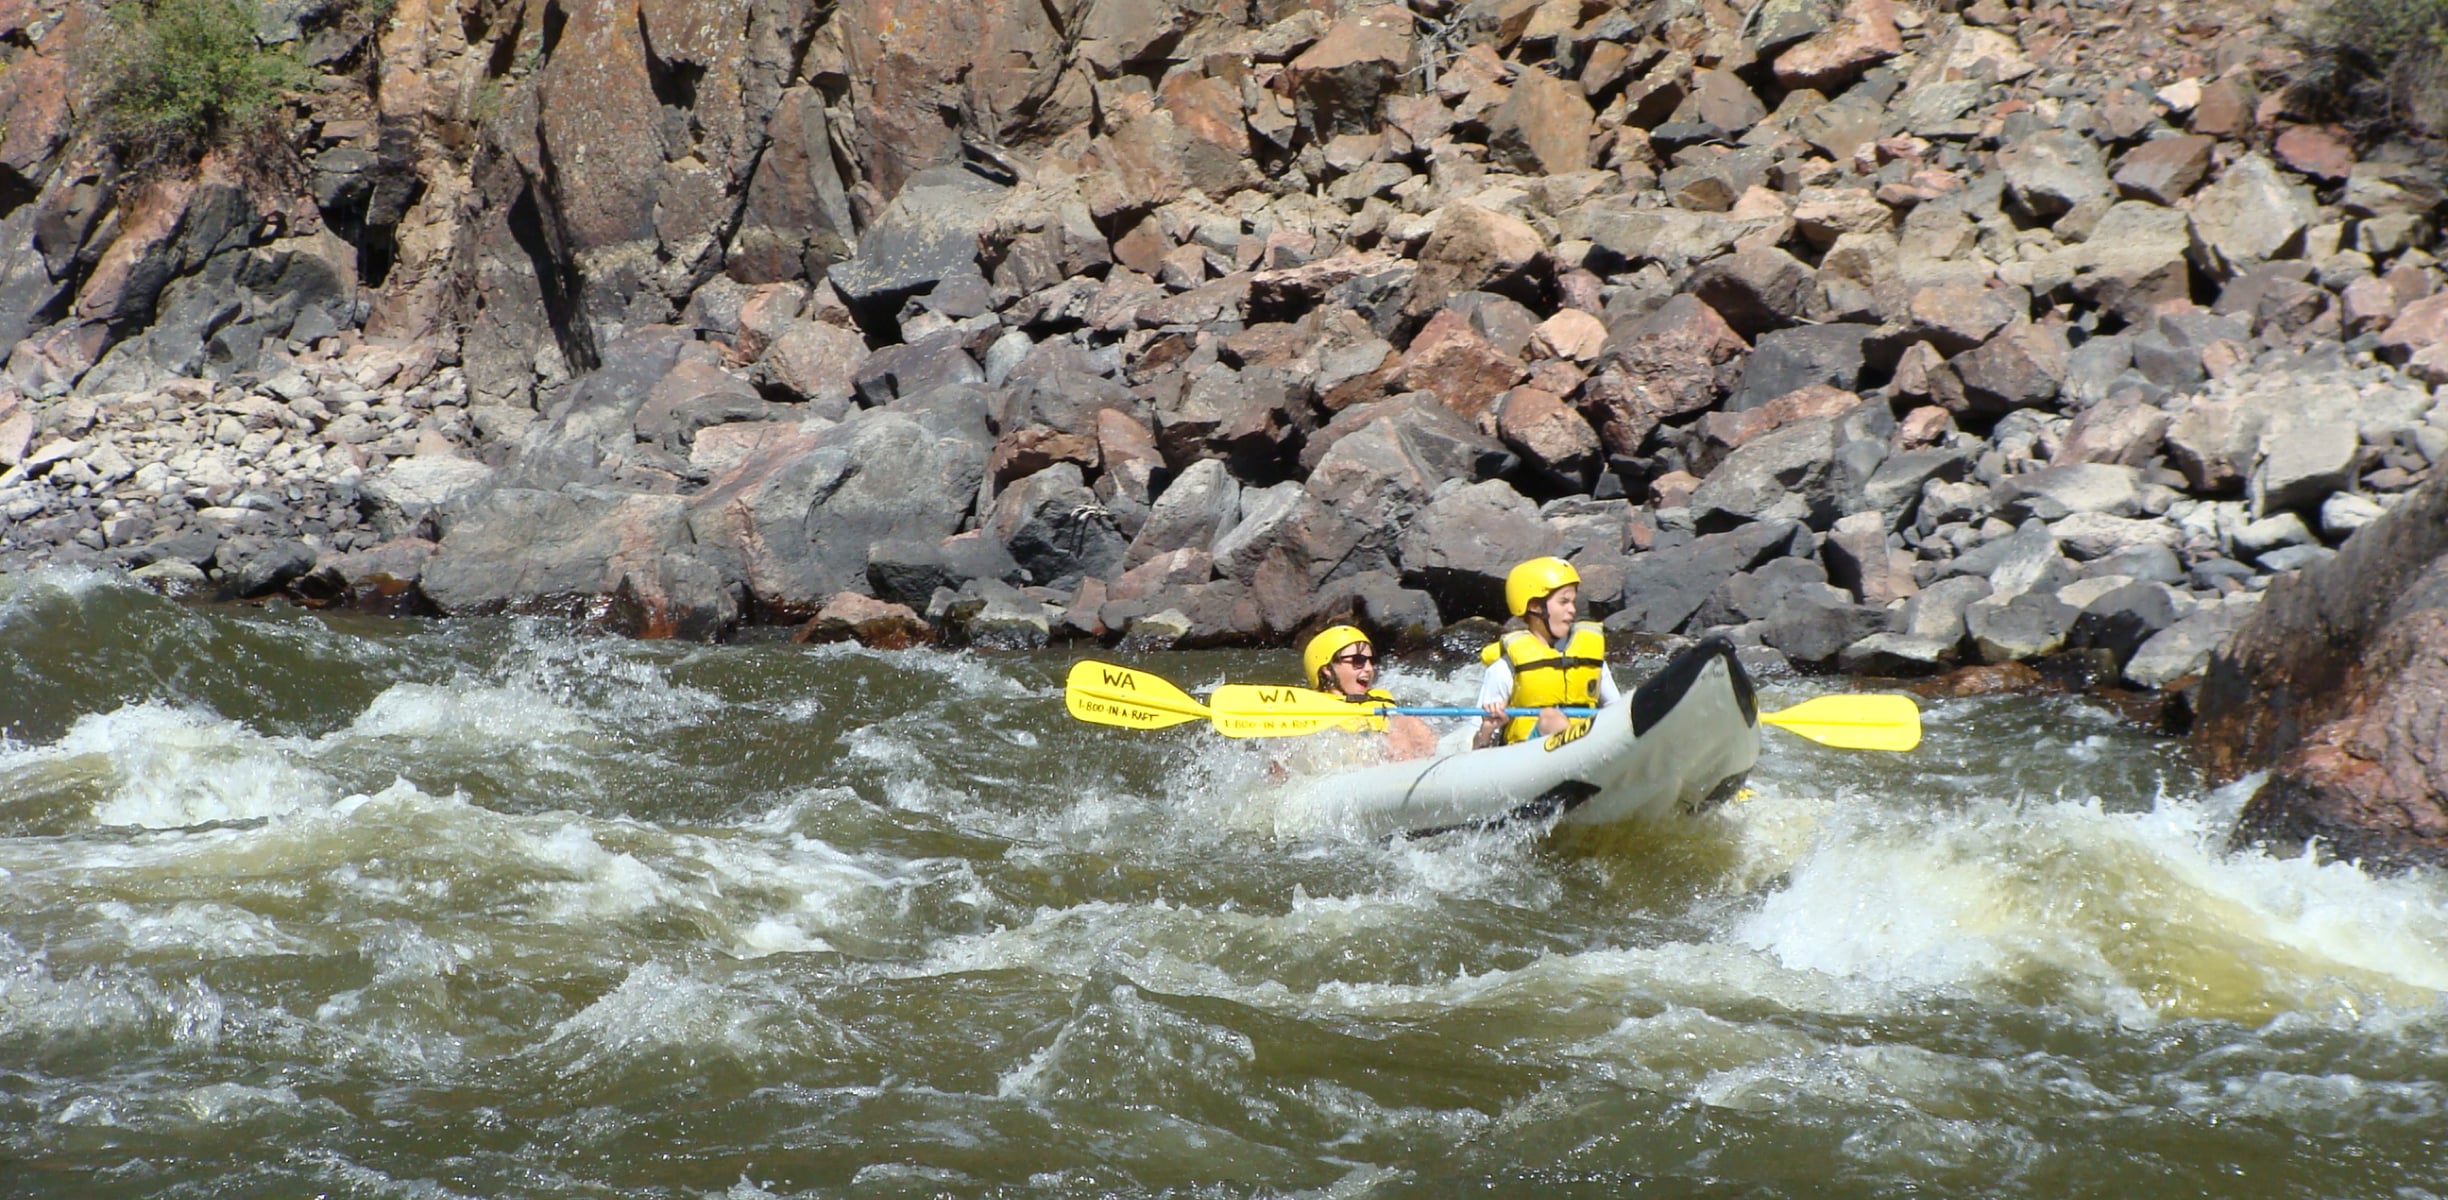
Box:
[1471, 558, 1623, 747]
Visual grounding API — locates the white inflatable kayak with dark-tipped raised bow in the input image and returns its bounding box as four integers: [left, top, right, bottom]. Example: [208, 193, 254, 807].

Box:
[1275, 637, 1760, 838]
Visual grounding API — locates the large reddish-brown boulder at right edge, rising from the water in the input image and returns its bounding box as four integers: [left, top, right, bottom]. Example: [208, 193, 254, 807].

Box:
[2193, 462, 2448, 864]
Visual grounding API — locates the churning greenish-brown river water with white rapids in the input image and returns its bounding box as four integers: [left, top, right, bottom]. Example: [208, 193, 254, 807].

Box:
[0, 571, 2448, 1200]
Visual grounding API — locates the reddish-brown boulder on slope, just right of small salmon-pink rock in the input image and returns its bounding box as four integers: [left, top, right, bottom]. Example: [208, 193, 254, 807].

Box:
[1584, 294, 1750, 456]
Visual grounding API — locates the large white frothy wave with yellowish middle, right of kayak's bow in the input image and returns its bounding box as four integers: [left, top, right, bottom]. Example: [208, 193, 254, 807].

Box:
[1728, 783, 2448, 1021]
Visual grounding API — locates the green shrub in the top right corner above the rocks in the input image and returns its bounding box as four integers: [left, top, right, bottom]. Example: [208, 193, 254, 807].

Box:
[2296, 0, 2448, 135]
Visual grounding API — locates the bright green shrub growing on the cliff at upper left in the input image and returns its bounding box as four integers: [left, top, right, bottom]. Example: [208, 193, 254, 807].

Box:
[98, 0, 306, 162]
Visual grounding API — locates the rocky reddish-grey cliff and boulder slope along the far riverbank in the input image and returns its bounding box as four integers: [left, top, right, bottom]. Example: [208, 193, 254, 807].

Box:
[0, 0, 2448, 686]
